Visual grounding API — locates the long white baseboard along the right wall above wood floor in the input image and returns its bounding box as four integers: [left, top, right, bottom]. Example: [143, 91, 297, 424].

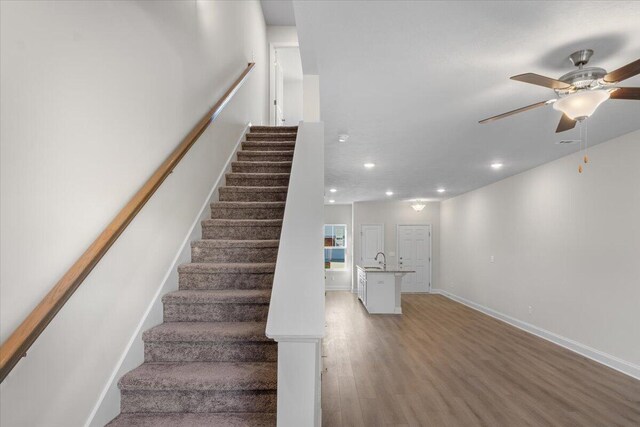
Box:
[431, 289, 640, 380]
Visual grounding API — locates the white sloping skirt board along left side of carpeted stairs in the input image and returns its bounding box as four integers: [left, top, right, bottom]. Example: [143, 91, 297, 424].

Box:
[85, 123, 251, 427]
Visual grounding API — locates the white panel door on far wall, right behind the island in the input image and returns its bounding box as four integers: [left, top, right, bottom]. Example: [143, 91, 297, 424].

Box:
[398, 225, 431, 292]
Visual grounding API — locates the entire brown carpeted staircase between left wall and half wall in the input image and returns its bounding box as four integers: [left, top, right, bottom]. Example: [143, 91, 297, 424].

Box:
[109, 126, 297, 427]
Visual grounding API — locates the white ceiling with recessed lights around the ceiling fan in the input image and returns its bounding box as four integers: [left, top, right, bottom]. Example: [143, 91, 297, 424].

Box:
[293, 1, 640, 203]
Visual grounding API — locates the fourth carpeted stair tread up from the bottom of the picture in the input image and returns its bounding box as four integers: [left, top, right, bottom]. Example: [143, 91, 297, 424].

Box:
[162, 289, 271, 304]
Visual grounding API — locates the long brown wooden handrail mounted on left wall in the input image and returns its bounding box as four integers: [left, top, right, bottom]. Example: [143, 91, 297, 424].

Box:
[0, 62, 255, 382]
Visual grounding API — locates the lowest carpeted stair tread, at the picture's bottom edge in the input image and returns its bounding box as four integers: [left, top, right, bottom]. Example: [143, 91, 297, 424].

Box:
[107, 413, 276, 427]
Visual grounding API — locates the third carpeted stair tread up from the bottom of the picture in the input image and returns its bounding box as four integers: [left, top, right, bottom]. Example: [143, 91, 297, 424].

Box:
[142, 322, 271, 342]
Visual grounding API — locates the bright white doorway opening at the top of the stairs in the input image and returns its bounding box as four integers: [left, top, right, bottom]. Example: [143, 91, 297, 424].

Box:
[269, 44, 302, 126]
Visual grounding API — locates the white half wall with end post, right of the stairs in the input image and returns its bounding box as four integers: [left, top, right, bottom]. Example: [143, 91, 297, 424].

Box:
[266, 122, 324, 427]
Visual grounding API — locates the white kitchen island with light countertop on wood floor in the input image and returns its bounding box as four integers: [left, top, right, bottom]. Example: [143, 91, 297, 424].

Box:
[357, 265, 413, 314]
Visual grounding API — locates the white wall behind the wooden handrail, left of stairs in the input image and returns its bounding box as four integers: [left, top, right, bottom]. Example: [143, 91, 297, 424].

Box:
[0, 1, 268, 426]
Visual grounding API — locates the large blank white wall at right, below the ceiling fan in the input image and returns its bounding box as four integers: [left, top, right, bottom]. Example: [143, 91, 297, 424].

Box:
[440, 131, 640, 375]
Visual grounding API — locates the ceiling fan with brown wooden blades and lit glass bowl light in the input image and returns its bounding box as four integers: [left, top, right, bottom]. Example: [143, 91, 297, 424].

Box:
[479, 49, 640, 133]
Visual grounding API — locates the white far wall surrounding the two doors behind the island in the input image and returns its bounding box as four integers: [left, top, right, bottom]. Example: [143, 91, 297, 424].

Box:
[353, 201, 440, 288]
